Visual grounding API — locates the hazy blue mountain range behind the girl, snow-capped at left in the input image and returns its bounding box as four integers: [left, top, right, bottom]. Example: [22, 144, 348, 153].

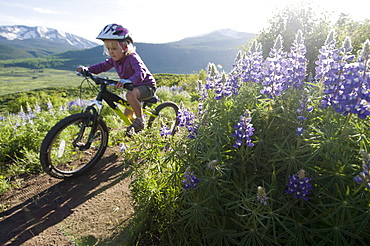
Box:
[0, 25, 254, 74]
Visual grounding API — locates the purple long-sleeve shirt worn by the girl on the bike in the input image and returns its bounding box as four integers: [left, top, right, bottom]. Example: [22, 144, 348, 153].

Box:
[88, 53, 156, 86]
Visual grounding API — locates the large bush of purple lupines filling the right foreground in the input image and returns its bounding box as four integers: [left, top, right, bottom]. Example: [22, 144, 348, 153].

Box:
[124, 31, 370, 245]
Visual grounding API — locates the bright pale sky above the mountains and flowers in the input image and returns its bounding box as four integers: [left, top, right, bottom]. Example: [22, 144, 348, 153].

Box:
[0, 0, 370, 43]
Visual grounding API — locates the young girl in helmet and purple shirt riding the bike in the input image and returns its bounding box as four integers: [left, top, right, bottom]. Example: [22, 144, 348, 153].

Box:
[77, 24, 156, 132]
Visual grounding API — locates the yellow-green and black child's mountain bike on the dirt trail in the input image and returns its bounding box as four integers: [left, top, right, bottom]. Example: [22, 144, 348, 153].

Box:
[40, 71, 179, 179]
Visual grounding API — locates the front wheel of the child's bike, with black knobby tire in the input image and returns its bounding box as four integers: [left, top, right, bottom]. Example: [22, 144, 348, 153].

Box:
[40, 113, 108, 179]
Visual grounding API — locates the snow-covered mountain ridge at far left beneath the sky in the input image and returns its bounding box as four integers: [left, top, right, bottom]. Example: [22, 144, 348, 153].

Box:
[0, 25, 98, 49]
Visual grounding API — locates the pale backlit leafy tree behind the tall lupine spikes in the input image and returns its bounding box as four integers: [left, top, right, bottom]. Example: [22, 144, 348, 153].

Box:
[257, 3, 331, 75]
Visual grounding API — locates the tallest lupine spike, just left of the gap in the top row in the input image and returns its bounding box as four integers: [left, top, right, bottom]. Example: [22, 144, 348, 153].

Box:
[285, 30, 307, 89]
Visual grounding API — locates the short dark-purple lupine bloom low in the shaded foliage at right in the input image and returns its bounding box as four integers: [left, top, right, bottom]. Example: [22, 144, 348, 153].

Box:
[285, 170, 312, 201]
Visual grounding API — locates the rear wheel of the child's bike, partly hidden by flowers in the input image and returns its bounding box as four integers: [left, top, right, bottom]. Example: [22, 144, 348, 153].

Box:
[148, 102, 179, 135]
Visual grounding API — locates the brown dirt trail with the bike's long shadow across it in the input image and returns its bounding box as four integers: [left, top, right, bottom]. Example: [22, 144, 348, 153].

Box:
[0, 148, 133, 246]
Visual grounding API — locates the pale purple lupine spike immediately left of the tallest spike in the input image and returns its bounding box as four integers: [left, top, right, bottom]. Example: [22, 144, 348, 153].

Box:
[261, 35, 288, 99]
